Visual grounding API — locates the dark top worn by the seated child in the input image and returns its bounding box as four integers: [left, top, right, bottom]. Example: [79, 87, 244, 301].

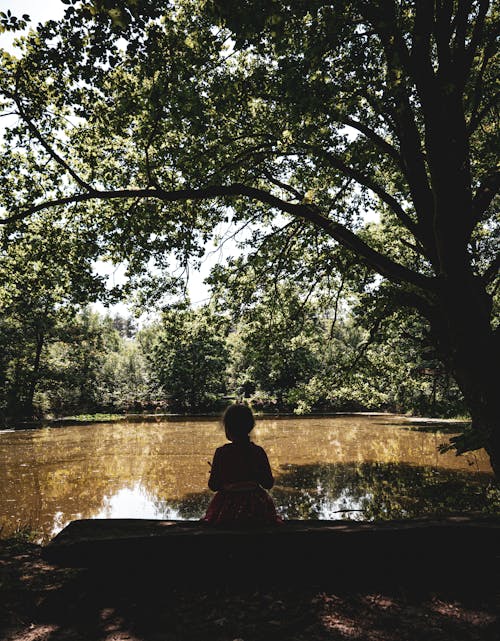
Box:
[208, 441, 274, 492]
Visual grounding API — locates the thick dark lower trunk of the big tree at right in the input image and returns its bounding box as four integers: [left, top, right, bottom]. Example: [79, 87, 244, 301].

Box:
[431, 276, 500, 479]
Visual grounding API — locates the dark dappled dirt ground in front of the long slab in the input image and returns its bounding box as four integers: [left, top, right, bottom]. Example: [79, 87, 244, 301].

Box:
[0, 540, 500, 641]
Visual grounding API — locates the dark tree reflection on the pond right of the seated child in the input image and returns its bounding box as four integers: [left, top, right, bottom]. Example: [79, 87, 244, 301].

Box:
[168, 462, 500, 520]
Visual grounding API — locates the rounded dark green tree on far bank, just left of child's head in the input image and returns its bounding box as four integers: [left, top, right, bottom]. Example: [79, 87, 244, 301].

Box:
[149, 307, 228, 411]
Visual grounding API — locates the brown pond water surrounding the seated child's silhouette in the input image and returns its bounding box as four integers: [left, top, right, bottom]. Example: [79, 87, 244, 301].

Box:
[0, 415, 492, 541]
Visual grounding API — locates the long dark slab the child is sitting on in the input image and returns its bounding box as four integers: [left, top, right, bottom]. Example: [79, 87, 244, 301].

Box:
[42, 516, 500, 585]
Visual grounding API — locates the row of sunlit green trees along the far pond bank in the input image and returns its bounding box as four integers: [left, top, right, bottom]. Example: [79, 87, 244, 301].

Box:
[0, 286, 465, 425]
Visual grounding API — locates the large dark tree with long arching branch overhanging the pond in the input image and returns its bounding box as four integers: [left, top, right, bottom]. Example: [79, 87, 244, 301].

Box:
[0, 0, 500, 475]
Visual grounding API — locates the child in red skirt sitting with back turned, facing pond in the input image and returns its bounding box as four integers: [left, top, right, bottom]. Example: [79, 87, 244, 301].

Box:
[202, 403, 282, 525]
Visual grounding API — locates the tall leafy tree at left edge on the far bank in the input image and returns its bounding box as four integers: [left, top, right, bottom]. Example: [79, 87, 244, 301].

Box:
[0, 216, 104, 418]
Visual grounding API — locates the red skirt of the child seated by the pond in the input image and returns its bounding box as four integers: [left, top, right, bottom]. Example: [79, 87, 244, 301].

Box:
[201, 486, 283, 526]
